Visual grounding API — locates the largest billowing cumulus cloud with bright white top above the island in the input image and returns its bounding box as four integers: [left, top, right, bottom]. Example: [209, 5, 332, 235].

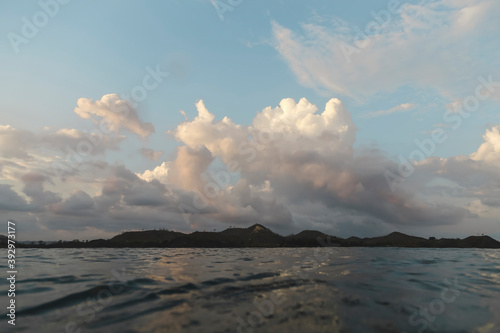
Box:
[158, 99, 470, 225]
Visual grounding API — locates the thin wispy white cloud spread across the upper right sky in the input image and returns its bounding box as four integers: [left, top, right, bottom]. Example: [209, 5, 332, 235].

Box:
[272, 0, 500, 99]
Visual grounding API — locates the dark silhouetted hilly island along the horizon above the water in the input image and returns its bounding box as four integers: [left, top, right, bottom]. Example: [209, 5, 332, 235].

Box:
[0, 224, 500, 248]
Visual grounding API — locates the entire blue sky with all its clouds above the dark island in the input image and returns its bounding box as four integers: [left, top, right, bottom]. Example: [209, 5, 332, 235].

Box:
[0, 0, 500, 240]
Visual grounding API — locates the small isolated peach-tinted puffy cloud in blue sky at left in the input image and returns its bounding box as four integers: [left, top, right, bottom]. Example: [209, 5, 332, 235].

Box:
[75, 94, 155, 139]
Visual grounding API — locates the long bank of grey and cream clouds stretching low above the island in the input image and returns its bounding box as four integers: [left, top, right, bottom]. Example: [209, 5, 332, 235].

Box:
[0, 95, 500, 236]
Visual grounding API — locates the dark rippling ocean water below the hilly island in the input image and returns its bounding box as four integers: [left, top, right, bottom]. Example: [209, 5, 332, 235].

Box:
[0, 248, 500, 333]
